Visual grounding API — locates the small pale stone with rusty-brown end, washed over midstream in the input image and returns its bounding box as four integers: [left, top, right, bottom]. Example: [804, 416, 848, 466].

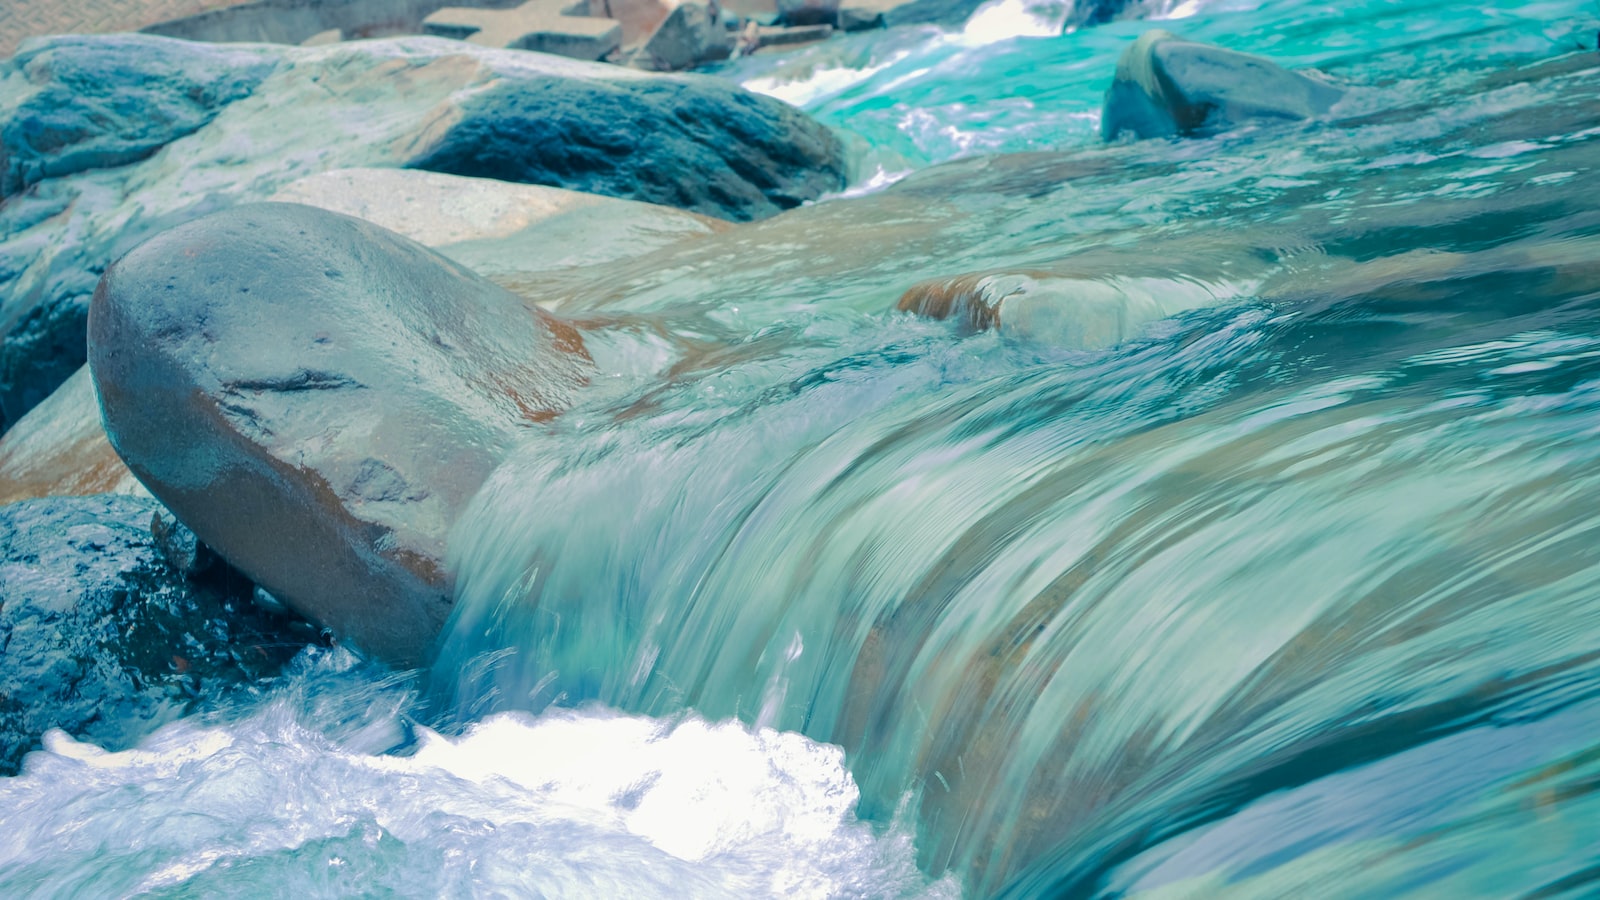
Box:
[894, 272, 1248, 344]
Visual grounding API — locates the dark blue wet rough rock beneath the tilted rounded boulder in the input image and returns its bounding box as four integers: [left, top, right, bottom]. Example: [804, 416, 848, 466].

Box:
[0, 495, 317, 775]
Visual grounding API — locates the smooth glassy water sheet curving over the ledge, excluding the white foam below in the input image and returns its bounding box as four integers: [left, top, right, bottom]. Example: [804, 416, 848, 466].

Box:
[442, 21, 1600, 897]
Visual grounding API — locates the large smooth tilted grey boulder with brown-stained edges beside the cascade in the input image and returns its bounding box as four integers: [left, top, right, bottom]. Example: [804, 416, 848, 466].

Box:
[90, 203, 590, 665]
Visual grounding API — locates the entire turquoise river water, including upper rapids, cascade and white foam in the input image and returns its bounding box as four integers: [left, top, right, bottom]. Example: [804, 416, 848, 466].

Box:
[0, 0, 1600, 897]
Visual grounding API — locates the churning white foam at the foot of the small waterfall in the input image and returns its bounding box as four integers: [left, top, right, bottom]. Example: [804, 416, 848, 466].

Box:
[0, 650, 958, 898]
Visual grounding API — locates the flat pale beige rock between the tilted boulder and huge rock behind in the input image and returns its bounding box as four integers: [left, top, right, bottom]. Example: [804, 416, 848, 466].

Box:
[272, 168, 731, 285]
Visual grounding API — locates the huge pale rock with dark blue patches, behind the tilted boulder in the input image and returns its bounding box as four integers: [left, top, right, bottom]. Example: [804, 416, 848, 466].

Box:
[0, 35, 843, 431]
